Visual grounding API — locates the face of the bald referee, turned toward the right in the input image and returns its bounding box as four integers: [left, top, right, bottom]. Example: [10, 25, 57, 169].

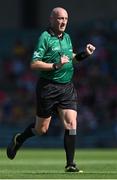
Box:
[51, 10, 68, 33]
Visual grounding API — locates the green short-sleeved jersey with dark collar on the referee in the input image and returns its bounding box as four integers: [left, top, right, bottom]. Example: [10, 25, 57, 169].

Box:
[32, 28, 73, 83]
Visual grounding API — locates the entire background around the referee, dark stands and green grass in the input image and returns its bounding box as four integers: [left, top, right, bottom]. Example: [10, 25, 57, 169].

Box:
[0, 0, 117, 179]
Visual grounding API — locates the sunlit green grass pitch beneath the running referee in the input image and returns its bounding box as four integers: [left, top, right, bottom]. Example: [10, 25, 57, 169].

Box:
[0, 149, 117, 179]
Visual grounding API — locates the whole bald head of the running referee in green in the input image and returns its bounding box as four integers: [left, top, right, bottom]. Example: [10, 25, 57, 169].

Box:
[50, 7, 68, 35]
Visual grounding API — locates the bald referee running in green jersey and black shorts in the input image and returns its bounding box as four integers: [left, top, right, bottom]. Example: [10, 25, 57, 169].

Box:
[7, 7, 95, 172]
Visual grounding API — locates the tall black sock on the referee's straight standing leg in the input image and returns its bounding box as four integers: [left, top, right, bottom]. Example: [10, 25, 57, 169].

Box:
[64, 129, 76, 165]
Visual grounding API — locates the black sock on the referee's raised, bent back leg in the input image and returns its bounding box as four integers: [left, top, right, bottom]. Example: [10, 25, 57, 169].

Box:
[17, 123, 35, 143]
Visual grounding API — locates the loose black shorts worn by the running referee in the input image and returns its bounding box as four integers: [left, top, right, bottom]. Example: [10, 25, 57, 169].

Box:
[36, 79, 77, 118]
